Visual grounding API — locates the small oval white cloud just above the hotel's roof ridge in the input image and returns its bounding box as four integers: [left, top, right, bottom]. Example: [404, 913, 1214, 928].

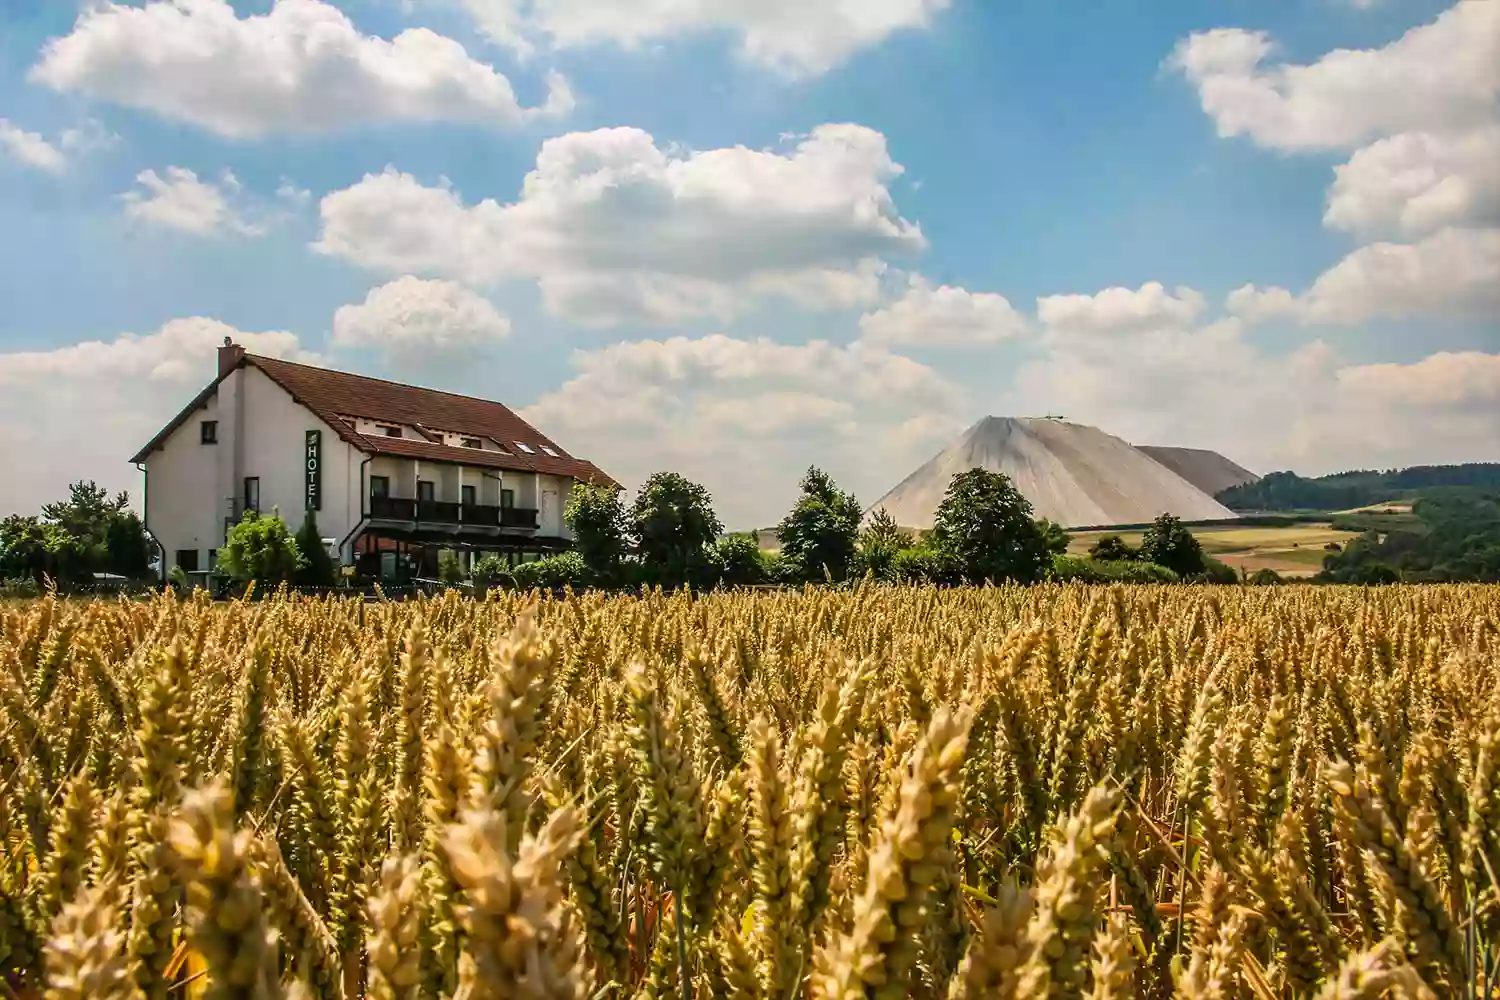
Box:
[333, 274, 510, 364]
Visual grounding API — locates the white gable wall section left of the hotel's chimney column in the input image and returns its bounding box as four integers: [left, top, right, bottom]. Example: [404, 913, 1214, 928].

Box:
[146, 396, 228, 570]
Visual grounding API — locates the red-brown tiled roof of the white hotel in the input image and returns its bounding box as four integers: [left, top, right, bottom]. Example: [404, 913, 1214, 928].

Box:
[132, 354, 618, 487]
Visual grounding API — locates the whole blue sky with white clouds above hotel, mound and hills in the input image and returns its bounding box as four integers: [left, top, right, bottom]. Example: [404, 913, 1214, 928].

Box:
[0, 0, 1500, 526]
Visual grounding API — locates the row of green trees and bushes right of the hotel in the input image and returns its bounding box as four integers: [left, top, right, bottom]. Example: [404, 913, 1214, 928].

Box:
[528, 468, 1236, 588]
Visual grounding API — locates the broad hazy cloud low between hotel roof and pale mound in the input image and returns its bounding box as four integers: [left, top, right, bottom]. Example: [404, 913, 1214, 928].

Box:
[522, 334, 966, 528]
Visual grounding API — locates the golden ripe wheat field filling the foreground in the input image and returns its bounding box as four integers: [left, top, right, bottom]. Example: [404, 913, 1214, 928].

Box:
[0, 585, 1500, 1000]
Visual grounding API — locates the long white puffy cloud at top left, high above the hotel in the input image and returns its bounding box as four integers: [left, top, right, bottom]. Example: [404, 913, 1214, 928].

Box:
[30, 0, 573, 138]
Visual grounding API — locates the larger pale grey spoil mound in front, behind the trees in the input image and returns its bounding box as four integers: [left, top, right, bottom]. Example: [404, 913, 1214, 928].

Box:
[872, 417, 1236, 529]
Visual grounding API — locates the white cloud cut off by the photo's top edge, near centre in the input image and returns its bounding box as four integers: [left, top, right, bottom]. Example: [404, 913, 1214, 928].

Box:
[462, 0, 951, 76]
